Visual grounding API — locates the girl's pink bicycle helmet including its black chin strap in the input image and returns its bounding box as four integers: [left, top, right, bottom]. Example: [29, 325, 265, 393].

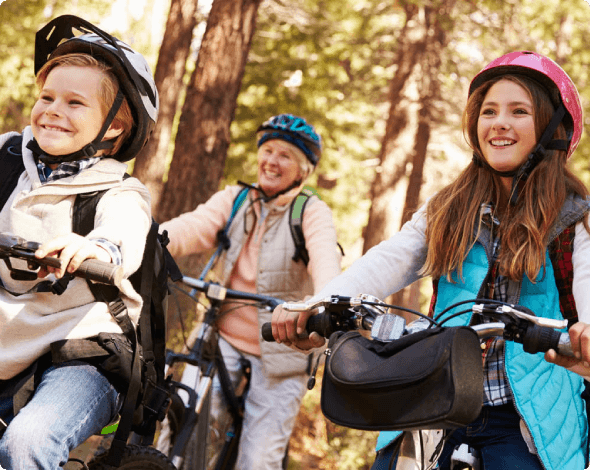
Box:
[468, 51, 583, 202]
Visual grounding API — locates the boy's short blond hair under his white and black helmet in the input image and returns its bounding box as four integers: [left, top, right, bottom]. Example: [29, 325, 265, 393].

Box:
[36, 53, 135, 155]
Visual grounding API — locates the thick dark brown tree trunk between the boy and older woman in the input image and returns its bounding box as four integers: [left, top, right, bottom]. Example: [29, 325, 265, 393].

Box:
[157, 0, 261, 228]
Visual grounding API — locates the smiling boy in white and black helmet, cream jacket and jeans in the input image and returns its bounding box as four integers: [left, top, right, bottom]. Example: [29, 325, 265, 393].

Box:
[0, 15, 158, 470]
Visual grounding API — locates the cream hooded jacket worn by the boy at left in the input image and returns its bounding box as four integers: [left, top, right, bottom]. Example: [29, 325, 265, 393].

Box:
[0, 127, 151, 380]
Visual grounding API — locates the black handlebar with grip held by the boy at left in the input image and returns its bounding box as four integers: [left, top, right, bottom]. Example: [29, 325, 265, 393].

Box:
[0, 233, 123, 285]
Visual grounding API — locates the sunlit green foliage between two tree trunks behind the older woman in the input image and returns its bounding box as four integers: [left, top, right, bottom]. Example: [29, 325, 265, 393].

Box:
[226, 1, 397, 258]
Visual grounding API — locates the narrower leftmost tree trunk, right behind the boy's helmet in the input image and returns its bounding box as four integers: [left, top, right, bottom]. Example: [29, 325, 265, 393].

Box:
[133, 0, 197, 213]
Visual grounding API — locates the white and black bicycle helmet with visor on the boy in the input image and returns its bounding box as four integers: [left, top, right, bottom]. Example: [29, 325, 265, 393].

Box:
[35, 15, 159, 163]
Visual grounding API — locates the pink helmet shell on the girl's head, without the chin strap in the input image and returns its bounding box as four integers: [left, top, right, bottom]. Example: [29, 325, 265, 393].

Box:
[469, 51, 583, 158]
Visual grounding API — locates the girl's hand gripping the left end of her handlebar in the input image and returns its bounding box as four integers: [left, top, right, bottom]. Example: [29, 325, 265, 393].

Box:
[272, 305, 325, 351]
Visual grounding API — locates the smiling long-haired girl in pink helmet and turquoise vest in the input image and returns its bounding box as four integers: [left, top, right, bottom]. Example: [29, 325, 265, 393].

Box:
[273, 52, 590, 470]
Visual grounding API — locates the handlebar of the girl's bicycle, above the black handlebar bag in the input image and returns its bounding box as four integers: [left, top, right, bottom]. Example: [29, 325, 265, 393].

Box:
[262, 294, 573, 356]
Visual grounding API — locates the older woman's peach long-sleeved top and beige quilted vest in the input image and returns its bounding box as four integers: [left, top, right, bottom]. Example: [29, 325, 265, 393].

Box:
[161, 186, 341, 376]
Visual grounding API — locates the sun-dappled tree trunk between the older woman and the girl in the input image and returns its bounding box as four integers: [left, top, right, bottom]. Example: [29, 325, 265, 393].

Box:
[363, 0, 455, 314]
